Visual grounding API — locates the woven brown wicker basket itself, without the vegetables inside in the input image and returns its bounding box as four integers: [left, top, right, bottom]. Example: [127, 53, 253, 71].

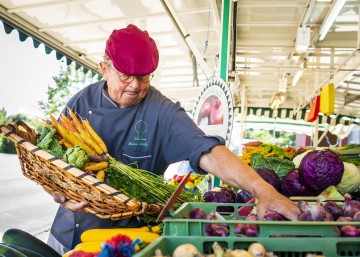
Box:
[0, 125, 163, 220]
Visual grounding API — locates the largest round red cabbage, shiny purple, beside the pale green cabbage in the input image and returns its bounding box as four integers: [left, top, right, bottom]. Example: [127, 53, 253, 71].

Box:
[299, 149, 344, 194]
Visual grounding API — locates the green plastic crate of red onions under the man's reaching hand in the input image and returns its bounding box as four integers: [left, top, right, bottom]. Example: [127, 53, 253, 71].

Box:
[162, 203, 360, 237]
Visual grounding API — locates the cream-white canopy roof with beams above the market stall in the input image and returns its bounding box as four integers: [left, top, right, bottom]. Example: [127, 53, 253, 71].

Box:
[0, 0, 360, 127]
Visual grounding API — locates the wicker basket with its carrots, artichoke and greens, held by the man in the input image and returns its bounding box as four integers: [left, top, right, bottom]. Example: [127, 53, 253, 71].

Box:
[0, 109, 197, 220]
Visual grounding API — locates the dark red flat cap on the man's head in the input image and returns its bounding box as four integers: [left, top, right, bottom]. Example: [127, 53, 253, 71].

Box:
[105, 24, 159, 76]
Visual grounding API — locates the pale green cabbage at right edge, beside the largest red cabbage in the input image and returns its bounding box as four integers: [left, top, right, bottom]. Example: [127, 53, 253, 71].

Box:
[336, 162, 360, 194]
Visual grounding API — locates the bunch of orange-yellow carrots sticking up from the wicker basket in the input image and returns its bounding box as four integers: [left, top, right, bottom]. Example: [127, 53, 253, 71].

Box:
[50, 107, 108, 166]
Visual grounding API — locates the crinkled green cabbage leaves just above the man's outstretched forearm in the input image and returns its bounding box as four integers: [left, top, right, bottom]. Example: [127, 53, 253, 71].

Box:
[250, 153, 295, 178]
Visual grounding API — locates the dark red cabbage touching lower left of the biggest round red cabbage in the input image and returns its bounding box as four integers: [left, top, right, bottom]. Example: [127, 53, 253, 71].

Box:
[281, 169, 315, 197]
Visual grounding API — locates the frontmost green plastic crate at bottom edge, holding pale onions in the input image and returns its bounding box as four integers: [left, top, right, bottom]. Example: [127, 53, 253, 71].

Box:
[135, 236, 360, 257]
